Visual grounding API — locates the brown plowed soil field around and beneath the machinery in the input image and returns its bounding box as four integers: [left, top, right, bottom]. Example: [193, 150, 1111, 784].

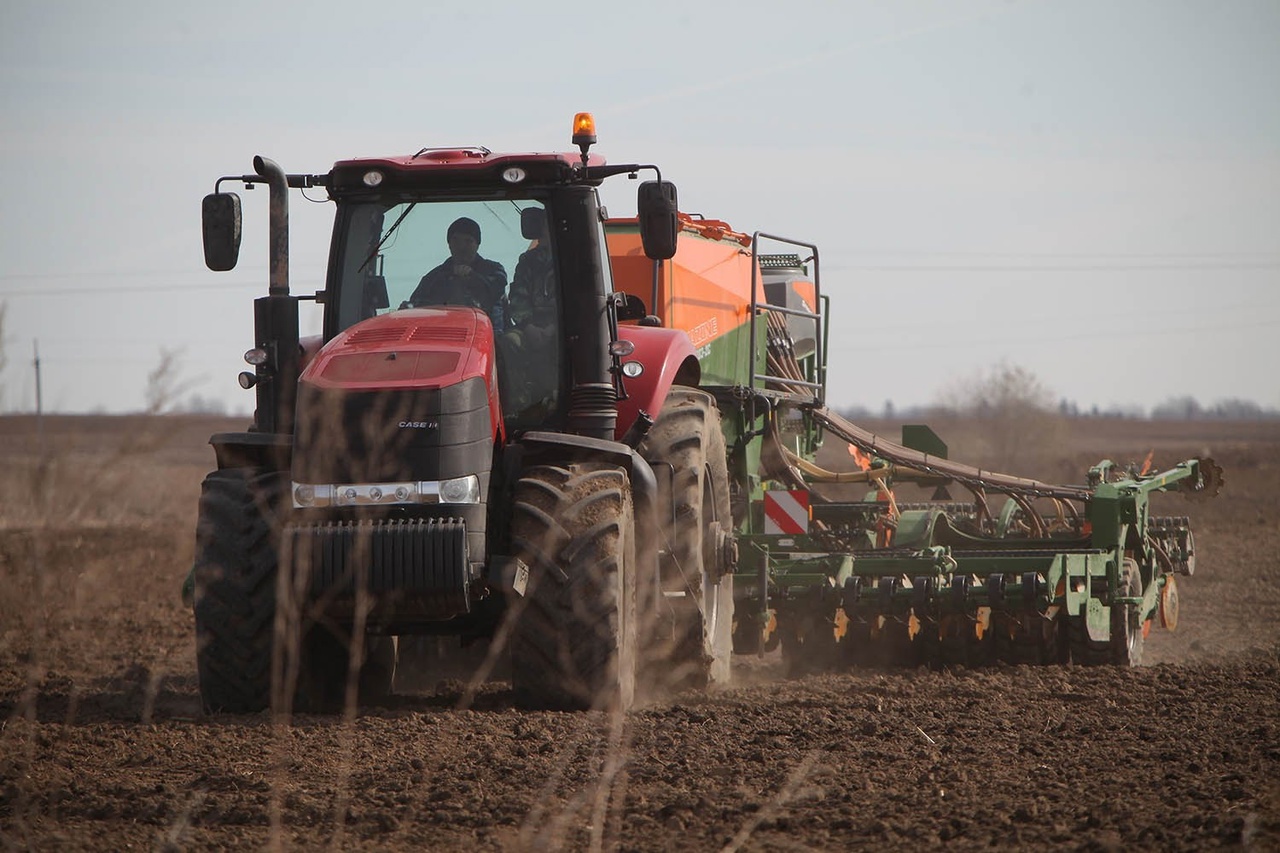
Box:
[0, 418, 1280, 850]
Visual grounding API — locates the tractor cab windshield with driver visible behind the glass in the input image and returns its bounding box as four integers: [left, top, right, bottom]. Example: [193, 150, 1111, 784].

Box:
[330, 199, 562, 428]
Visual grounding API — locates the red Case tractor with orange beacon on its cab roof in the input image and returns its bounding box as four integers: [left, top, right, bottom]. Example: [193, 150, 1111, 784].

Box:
[191, 114, 736, 712]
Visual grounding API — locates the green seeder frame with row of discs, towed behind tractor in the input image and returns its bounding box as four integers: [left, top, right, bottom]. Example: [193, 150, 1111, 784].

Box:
[737, 422, 1221, 665]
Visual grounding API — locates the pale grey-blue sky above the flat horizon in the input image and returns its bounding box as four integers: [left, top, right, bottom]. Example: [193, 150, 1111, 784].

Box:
[0, 0, 1280, 414]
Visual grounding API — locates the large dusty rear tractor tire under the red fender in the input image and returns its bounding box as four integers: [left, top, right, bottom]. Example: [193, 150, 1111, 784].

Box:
[639, 387, 733, 689]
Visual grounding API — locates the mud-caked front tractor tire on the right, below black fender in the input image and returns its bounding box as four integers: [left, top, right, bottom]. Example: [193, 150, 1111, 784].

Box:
[511, 462, 636, 711]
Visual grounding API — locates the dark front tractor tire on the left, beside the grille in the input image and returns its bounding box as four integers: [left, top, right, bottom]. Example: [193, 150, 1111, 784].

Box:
[192, 467, 284, 713]
